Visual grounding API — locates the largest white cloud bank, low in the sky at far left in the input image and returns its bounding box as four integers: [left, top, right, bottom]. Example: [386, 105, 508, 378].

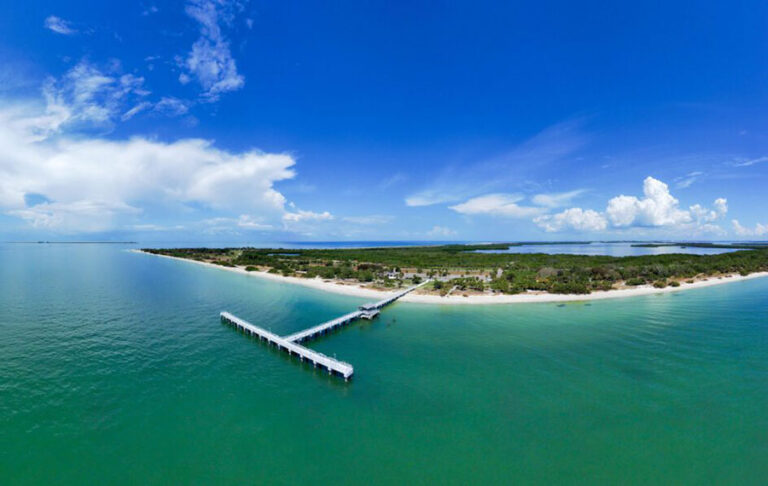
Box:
[0, 100, 324, 232]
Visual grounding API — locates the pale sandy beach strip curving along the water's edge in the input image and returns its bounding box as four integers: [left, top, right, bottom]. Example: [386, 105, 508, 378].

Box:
[129, 249, 768, 305]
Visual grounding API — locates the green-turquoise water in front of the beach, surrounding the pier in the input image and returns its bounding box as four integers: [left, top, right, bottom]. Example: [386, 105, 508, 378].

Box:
[0, 245, 768, 485]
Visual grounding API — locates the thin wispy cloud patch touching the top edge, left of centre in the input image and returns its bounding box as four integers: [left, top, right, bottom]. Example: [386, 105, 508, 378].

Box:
[179, 0, 245, 101]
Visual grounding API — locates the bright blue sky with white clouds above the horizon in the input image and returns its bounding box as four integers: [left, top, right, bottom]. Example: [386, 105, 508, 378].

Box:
[0, 0, 768, 242]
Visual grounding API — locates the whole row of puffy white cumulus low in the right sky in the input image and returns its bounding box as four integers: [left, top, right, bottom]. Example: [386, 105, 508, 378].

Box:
[534, 177, 728, 233]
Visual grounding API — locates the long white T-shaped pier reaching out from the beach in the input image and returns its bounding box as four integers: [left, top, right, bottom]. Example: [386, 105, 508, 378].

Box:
[221, 280, 429, 381]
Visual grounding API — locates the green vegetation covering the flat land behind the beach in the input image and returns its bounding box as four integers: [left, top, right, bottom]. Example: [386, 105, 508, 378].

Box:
[144, 243, 768, 294]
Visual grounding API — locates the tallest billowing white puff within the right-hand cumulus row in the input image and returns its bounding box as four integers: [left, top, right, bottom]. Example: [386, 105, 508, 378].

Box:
[606, 177, 692, 228]
